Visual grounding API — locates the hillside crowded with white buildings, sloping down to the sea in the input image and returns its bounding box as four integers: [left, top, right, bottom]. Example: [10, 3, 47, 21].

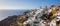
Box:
[0, 5, 60, 26]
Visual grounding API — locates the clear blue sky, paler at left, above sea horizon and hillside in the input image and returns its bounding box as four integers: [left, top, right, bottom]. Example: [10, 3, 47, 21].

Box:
[0, 0, 60, 10]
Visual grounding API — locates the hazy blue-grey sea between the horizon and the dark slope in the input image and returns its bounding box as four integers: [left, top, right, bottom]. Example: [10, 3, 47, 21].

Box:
[0, 10, 26, 21]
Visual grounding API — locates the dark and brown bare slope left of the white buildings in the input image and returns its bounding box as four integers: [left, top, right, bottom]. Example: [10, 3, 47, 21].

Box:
[0, 15, 27, 26]
